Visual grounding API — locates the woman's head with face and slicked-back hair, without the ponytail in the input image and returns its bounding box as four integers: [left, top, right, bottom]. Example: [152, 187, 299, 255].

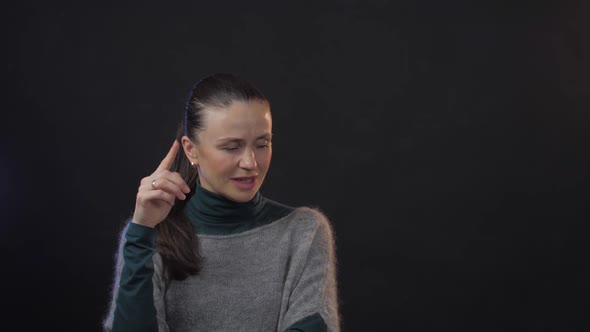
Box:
[180, 74, 272, 202]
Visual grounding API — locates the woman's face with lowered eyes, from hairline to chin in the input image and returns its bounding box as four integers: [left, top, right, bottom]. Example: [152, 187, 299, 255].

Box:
[187, 100, 272, 202]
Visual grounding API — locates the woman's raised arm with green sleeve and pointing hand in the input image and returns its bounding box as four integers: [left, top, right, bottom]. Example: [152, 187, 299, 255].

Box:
[104, 140, 190, 332]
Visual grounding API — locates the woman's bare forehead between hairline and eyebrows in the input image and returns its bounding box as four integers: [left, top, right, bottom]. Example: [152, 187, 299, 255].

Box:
[201, 100, 272, 139]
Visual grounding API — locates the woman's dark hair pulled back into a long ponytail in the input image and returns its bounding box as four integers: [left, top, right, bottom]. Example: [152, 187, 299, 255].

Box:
[156, 73, 268, 281]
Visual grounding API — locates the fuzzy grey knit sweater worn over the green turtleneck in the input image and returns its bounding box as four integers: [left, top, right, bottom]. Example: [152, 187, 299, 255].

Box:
[104, 207, 340, 331]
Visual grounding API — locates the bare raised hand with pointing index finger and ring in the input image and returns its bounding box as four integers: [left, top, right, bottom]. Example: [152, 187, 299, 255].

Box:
[133, 140, 190, 228]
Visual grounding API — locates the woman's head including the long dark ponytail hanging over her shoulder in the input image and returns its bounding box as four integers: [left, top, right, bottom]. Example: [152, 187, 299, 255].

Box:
[157, 74, 272, 281]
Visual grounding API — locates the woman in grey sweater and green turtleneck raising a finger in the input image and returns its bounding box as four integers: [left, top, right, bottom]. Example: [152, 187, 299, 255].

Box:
[103, 74, 340, 332]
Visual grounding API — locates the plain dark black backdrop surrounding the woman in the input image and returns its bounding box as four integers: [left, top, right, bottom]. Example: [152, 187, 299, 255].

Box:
[0, 0, 590, 331]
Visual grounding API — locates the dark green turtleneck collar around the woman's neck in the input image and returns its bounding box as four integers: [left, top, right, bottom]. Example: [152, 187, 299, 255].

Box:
[185, 179, 293, 235]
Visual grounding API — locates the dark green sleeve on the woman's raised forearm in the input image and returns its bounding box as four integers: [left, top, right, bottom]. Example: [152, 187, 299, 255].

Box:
[113, 223, 158, 332]
